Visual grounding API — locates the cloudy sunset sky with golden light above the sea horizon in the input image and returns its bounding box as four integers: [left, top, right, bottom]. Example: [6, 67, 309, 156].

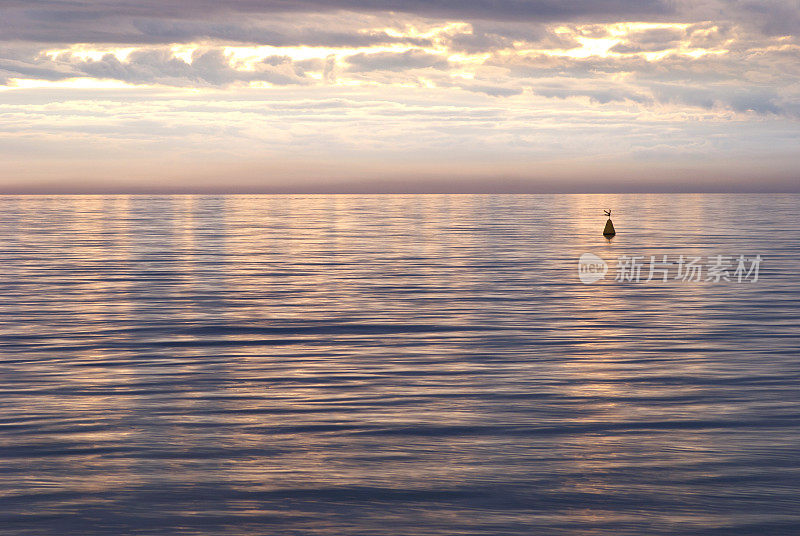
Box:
[0, 0, 800, 193]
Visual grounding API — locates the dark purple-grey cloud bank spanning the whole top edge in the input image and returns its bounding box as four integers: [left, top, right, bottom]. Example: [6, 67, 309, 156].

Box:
[0, 0, 800, 51]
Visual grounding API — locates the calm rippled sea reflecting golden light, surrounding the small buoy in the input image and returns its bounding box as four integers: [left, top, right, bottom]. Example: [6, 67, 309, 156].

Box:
[0, 195, 800, 536]
